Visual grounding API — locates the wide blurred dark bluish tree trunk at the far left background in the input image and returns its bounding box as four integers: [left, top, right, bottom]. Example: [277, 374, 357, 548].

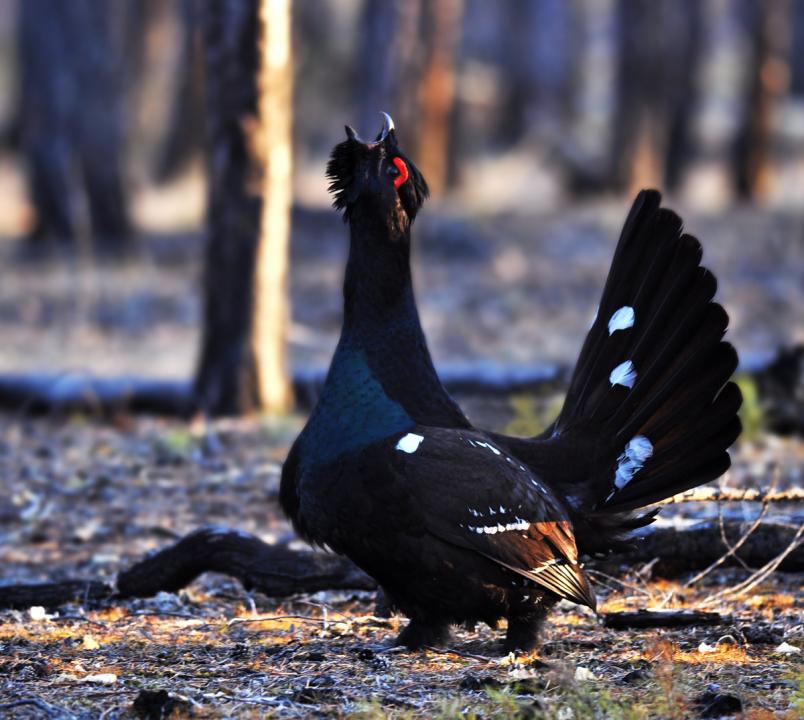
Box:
[20, 0, 131, 254]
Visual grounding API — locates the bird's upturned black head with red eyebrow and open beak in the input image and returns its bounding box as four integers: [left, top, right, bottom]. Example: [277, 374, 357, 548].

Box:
[327, 113, 428, 227]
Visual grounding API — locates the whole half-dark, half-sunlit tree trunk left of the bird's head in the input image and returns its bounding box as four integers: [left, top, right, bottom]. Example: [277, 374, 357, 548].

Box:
[195, 0, 291, 415]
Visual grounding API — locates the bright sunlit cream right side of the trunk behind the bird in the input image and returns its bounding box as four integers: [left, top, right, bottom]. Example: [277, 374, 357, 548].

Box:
[252, 0, 293, 412]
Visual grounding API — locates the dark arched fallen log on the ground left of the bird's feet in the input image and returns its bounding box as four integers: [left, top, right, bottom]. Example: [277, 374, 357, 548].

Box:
[117, 527, 377, 598]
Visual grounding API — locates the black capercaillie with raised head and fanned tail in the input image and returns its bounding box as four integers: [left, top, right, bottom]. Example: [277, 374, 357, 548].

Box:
[280, 116, 741, 651]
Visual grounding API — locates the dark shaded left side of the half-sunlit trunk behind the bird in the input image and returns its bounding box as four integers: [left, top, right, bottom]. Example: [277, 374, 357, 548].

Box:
[195, 0, 260, 415]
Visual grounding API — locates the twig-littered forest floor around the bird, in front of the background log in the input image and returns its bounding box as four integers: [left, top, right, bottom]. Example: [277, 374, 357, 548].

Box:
[0, 417, 804, 720]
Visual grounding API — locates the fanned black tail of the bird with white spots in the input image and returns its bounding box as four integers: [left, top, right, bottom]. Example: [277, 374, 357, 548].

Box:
[508, 191, 741, 550]
